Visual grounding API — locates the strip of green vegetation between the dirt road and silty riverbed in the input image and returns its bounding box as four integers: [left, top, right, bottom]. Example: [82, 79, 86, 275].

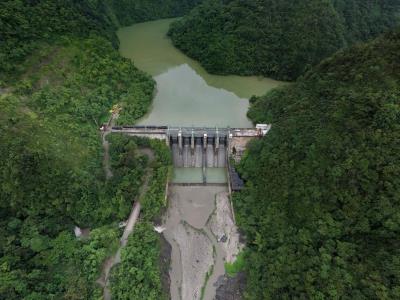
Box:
[110, 135, 171, 300]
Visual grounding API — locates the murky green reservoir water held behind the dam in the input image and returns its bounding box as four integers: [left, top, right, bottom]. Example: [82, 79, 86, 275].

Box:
[118, 19, 282, 127]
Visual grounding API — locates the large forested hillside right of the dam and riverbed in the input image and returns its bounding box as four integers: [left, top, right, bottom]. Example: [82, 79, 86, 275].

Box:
[234, 30, 400, 300]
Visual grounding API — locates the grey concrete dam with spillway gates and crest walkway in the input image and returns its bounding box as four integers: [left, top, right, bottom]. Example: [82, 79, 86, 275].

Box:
[112, 124, 271, 184]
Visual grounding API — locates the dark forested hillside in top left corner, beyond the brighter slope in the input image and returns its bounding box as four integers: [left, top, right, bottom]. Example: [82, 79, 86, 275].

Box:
[0, 0, 199, 82]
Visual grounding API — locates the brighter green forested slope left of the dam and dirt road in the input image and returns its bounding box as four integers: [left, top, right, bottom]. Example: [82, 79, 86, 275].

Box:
[0, 37, 153, 299]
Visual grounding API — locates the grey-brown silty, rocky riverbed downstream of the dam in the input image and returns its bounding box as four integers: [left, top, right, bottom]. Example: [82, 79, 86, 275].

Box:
[163, 186, 242, 300]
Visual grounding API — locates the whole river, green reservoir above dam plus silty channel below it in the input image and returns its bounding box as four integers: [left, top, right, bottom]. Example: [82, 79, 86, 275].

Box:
[117, 19, 282, 300]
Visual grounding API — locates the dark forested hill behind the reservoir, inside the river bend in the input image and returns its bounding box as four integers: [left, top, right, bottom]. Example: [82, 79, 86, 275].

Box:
[169, 0, 400, 80]
